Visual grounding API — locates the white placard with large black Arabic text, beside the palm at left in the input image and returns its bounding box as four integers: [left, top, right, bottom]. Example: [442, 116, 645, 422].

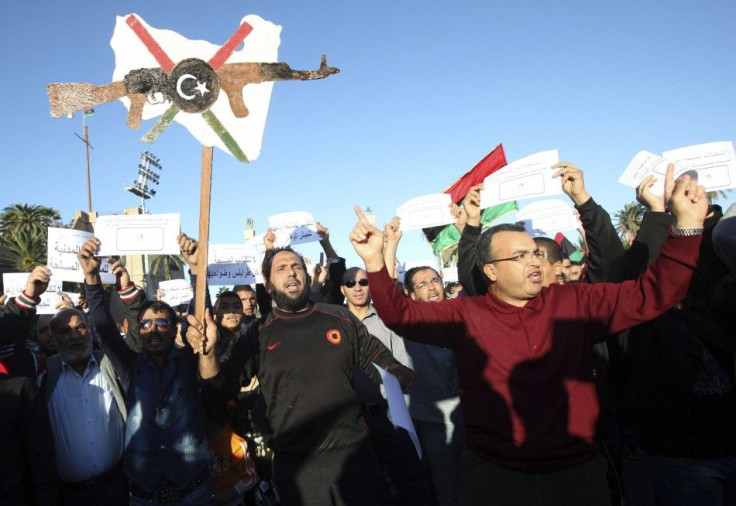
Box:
[47, 227, 115, 285]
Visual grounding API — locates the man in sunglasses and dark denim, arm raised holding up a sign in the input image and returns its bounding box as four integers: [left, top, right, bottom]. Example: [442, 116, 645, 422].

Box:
[77, 237, 214, 505]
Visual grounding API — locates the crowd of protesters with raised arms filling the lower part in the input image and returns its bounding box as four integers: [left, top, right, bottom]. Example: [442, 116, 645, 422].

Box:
[0, 162, 736, 506]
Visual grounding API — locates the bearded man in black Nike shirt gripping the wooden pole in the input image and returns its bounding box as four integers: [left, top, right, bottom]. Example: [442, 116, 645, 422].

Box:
[187, 247, 407, 505]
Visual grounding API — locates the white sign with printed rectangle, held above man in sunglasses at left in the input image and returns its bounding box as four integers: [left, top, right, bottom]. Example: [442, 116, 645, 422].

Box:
[95, 213, 180, 256]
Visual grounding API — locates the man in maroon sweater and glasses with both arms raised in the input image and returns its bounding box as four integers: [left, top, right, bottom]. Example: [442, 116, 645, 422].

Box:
[350, 175, 708, 506]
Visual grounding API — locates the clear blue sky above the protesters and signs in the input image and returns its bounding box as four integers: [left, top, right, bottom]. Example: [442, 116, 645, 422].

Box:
[0, 0, 736, 272]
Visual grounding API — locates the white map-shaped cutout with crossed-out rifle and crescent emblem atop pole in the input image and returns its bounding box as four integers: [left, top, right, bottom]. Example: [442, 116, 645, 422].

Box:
[47, 14, 339, 162]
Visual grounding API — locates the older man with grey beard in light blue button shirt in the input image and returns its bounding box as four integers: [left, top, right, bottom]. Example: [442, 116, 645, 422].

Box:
[42, 309, 128, 506]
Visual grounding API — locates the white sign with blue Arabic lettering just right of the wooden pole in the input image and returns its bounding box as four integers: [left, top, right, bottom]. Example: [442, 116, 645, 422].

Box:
[207, 244, 258, 286]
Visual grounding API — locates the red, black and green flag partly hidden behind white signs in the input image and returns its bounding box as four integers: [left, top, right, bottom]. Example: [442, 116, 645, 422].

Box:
[423, 144, 519, 255]
